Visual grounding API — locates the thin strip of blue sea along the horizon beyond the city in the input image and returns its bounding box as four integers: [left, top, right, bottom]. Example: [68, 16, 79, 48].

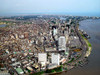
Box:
[0, 12, 100, 17]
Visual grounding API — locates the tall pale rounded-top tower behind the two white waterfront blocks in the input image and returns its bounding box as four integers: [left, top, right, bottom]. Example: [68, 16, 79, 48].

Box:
[58, 36, 66, 51]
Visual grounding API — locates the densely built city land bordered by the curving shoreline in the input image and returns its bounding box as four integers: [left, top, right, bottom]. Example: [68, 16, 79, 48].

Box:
[0, 15, 98, 75]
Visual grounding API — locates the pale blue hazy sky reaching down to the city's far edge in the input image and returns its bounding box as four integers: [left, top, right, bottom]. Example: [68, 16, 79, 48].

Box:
[0, 0, 100, 16]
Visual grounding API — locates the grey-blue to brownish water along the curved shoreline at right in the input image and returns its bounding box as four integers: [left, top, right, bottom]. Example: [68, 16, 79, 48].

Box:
[57, 19, 100, 75]
